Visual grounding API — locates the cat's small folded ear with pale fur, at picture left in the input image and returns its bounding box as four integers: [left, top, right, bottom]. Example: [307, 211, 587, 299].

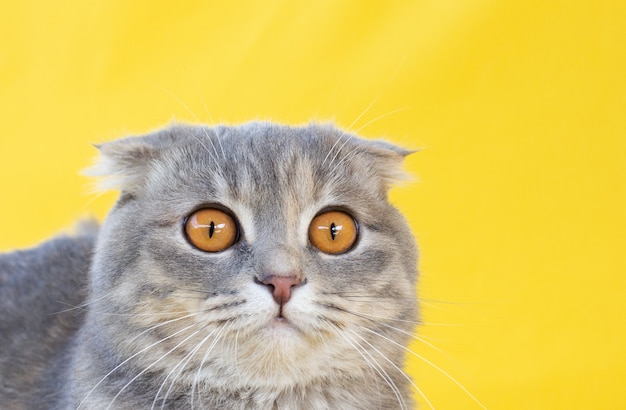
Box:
[83, 137, 158, 194]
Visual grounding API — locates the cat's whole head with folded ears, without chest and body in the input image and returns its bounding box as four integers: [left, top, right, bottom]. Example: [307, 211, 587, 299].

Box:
[90, 123, 416, 388]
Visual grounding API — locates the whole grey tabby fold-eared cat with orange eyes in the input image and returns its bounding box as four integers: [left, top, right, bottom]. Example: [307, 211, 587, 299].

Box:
[0, 122, 418, 410]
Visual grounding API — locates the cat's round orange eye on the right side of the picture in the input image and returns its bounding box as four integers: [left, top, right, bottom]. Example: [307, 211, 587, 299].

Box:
[309, 211, 358, 254]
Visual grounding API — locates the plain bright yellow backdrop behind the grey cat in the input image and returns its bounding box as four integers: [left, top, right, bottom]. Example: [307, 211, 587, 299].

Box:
[0, 0, 626, 409]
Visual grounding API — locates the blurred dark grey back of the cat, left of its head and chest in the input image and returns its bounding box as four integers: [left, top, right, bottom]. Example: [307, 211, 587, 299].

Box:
[0, 227, 96, 408]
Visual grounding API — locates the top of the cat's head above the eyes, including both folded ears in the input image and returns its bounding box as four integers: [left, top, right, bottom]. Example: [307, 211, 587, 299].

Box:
[90, 123, 408, 219]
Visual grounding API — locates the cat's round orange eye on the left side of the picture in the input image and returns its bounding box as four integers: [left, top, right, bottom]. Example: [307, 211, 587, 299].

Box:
[185, 208, 237, 252]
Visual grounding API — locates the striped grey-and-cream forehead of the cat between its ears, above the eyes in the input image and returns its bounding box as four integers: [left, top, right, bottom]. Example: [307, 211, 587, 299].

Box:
[158, 124, 360, 210]
